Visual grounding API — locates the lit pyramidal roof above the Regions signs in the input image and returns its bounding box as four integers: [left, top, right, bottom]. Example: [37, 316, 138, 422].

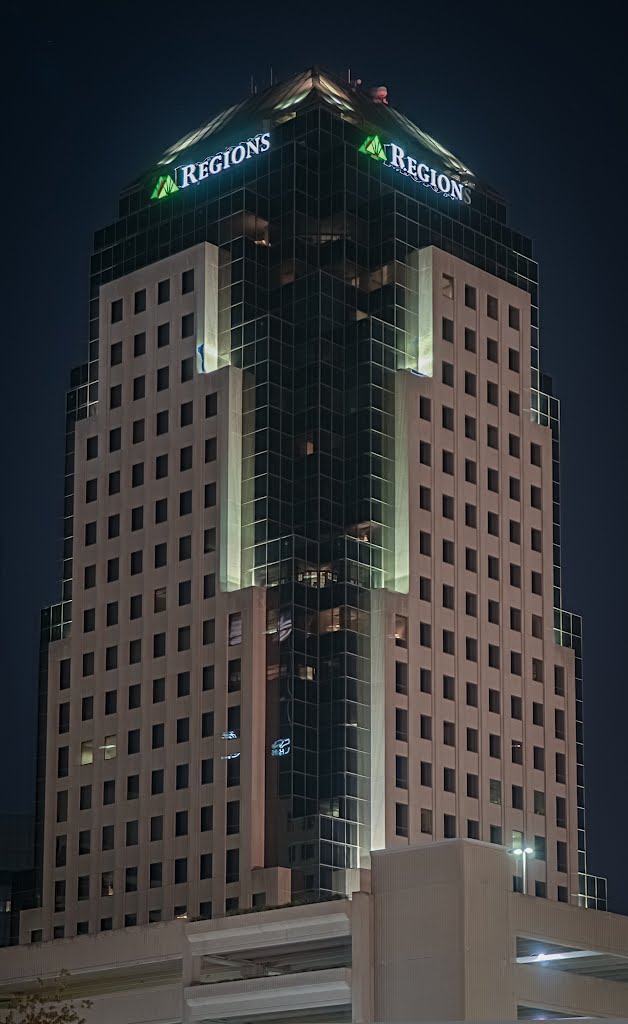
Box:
[152, 68, 475, 182]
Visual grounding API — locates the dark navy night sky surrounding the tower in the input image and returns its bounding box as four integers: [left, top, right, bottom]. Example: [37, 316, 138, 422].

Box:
[0, 0, 628, 912]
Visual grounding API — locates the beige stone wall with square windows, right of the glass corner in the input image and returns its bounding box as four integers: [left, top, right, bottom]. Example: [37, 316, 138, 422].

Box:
[373, 248, 577, 899]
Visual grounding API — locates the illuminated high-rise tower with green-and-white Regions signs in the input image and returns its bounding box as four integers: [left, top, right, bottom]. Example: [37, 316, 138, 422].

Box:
[23, 70, 604, 940]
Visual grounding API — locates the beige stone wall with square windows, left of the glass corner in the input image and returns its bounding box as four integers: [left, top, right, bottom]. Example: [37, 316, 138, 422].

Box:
[27, 244, 268, 941]
